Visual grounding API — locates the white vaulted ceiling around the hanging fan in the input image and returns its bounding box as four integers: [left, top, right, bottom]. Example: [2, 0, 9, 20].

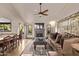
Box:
[0, 3, 79, 23]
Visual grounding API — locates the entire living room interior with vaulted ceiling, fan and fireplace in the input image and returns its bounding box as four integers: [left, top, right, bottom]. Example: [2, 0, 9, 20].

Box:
[0, 3, 79, 56]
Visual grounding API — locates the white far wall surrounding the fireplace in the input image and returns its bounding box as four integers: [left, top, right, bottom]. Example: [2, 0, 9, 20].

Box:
[26, 15, 49, 37]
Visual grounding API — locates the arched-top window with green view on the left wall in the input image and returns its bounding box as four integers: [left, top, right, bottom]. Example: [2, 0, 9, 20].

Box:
[0, 18, 11, 32]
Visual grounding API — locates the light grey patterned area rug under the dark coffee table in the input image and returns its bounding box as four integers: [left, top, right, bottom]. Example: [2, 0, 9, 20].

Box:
[22, 40, 54, 56]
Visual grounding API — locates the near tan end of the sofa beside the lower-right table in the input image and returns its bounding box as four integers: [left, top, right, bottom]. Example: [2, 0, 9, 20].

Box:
[62, 38, 79, 55]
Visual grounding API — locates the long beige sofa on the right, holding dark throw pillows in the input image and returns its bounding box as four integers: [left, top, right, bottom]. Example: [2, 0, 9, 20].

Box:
[48, 33, 79, 56]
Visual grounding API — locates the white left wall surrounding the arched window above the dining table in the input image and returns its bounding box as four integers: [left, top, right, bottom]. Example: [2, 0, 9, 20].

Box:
[0, 4, 24, 34]
